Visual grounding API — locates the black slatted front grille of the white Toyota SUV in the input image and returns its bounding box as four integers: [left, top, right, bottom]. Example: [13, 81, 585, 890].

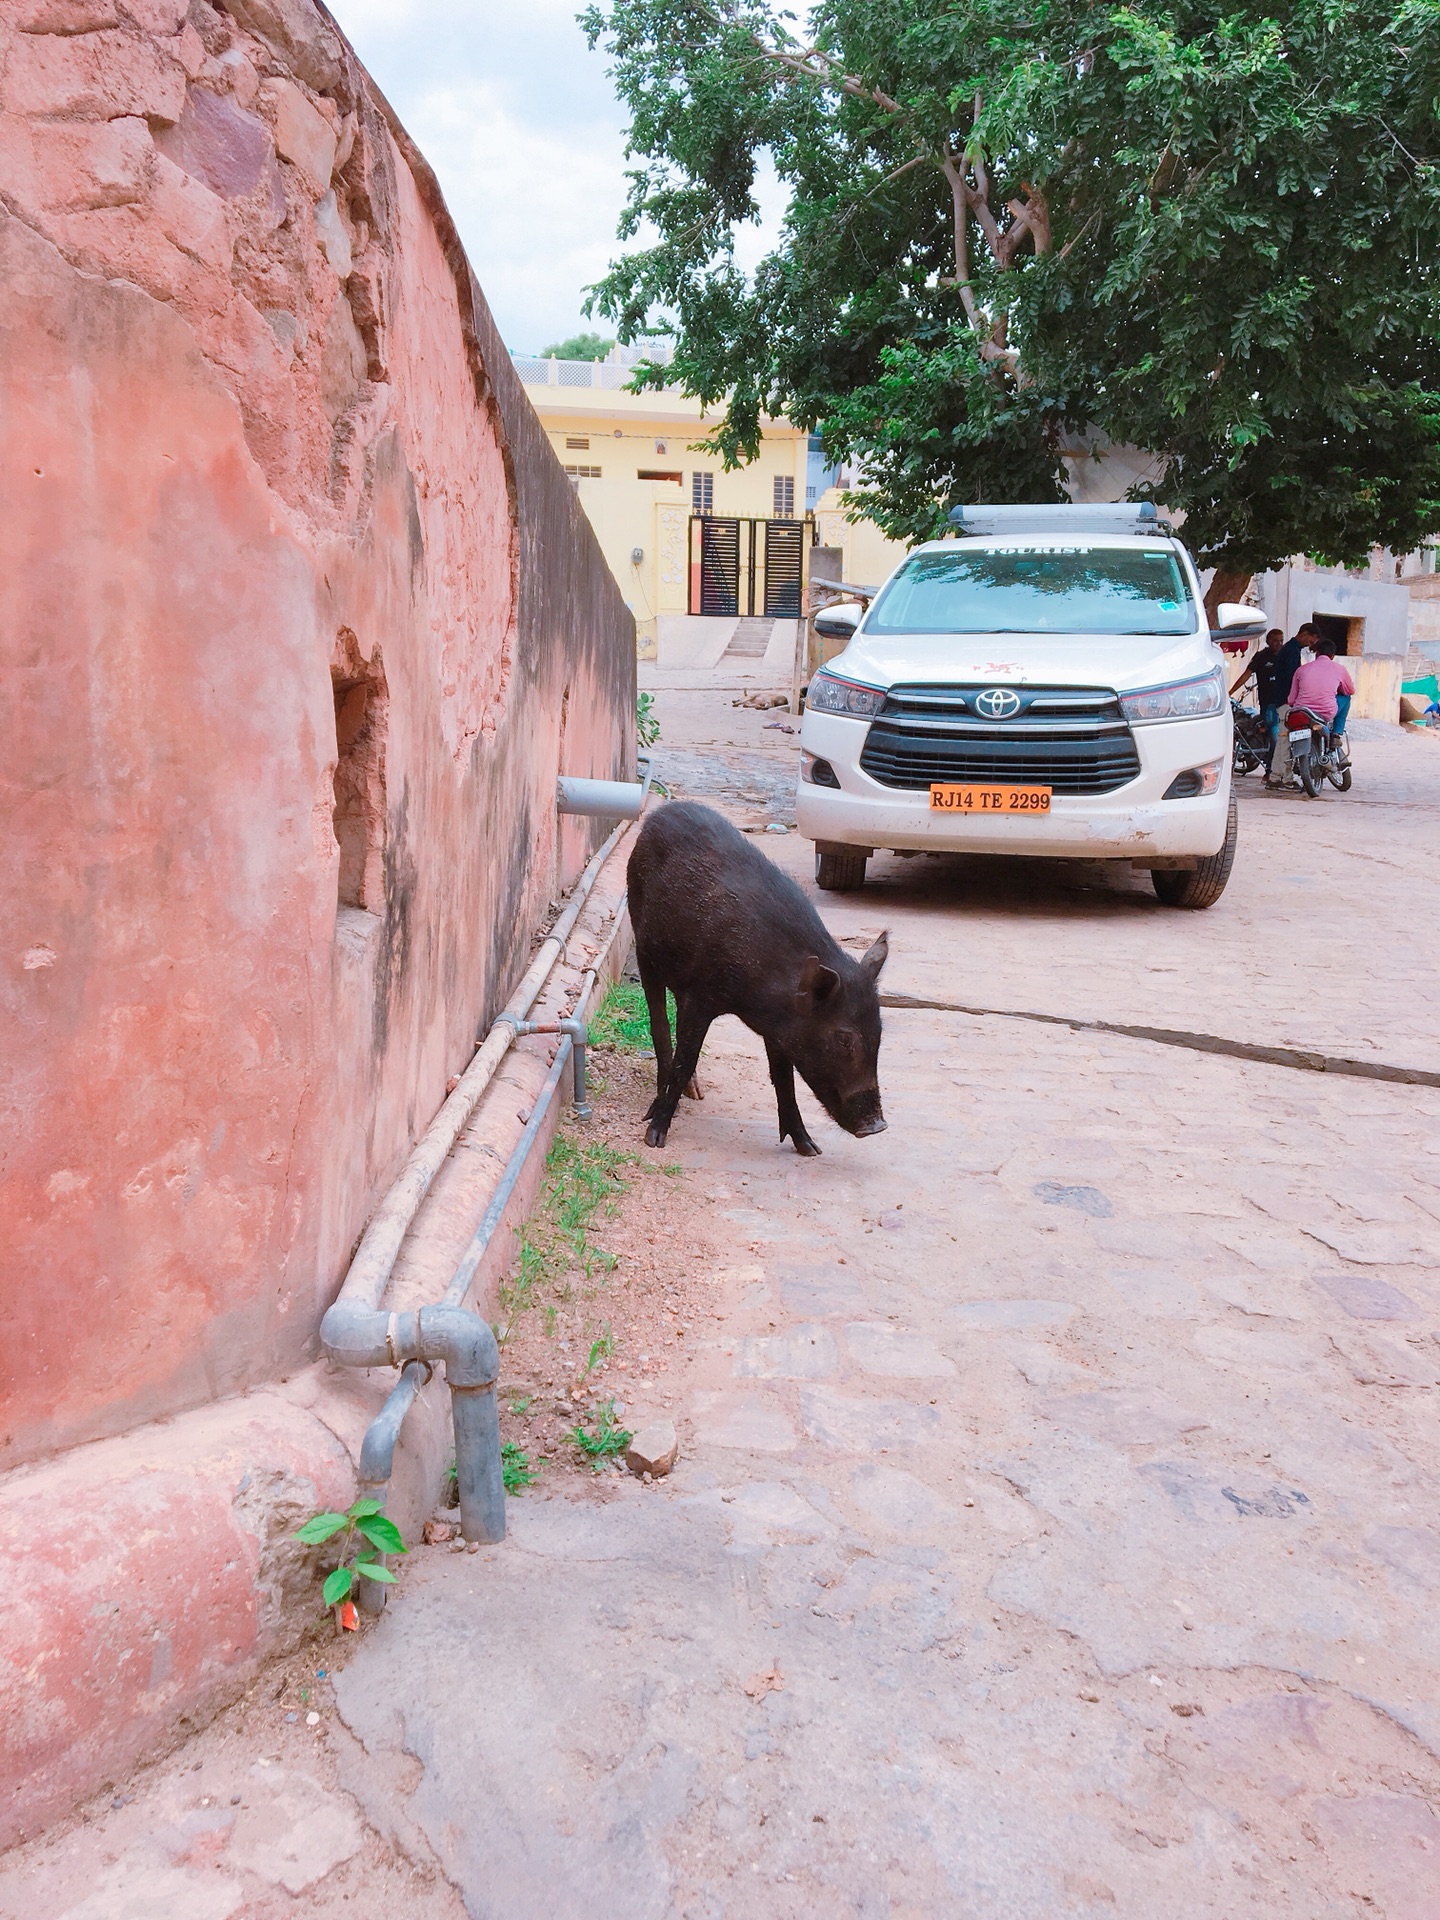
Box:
[860, 682, 1140, 793]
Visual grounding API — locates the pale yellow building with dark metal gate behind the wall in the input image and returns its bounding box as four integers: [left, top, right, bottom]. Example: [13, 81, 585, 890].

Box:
[515, 348, 902, 657]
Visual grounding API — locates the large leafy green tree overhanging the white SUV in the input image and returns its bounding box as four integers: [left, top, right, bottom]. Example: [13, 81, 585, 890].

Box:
[582, 0, 1440, 593]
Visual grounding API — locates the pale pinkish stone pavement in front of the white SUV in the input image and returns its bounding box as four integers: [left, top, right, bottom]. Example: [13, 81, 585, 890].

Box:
[336, 705, 1440, 1920]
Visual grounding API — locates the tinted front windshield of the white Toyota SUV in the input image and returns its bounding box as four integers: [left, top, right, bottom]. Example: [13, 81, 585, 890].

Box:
[866, 547, 1194, 634]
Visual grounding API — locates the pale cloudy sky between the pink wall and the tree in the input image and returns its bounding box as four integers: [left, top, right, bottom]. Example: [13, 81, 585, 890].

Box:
[328, 0, 791, 353]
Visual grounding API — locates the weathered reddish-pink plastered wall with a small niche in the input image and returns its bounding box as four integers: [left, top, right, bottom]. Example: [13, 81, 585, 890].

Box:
[0, 0, 634, 1465]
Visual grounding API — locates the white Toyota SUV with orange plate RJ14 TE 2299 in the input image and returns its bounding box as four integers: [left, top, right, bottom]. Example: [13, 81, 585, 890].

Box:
[797, 505, 1260, 906]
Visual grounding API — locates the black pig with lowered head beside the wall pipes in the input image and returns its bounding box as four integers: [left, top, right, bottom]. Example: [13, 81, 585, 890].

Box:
[626, 801, 889, 1154]
